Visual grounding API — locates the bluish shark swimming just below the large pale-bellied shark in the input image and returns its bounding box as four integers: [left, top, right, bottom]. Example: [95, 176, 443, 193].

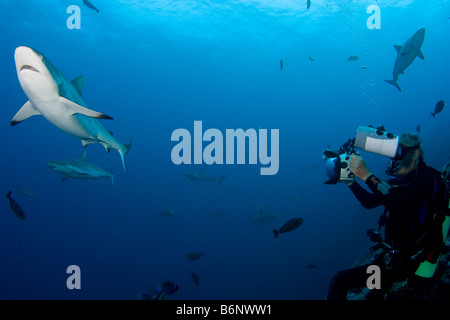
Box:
[47, 150, 114, 183]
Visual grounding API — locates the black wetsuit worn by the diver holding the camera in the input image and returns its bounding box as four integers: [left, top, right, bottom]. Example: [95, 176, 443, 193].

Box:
[327, 160, 437, 300]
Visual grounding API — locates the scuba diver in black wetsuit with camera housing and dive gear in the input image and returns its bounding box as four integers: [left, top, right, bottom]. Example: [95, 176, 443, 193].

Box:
[324, 127, 450, 300]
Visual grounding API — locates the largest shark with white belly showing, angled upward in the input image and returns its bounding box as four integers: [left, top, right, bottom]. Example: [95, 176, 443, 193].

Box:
[11, 47, 131, 171]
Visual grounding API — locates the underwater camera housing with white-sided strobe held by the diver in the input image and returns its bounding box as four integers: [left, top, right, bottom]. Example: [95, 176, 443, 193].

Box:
[323, 126, 399, 184]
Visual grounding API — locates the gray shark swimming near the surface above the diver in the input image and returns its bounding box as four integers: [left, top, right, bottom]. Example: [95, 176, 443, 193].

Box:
[384, 28, 425, 92]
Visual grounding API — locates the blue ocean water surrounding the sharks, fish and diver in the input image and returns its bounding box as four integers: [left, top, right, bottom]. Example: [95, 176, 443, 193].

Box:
[0, 0, 450, 300]
